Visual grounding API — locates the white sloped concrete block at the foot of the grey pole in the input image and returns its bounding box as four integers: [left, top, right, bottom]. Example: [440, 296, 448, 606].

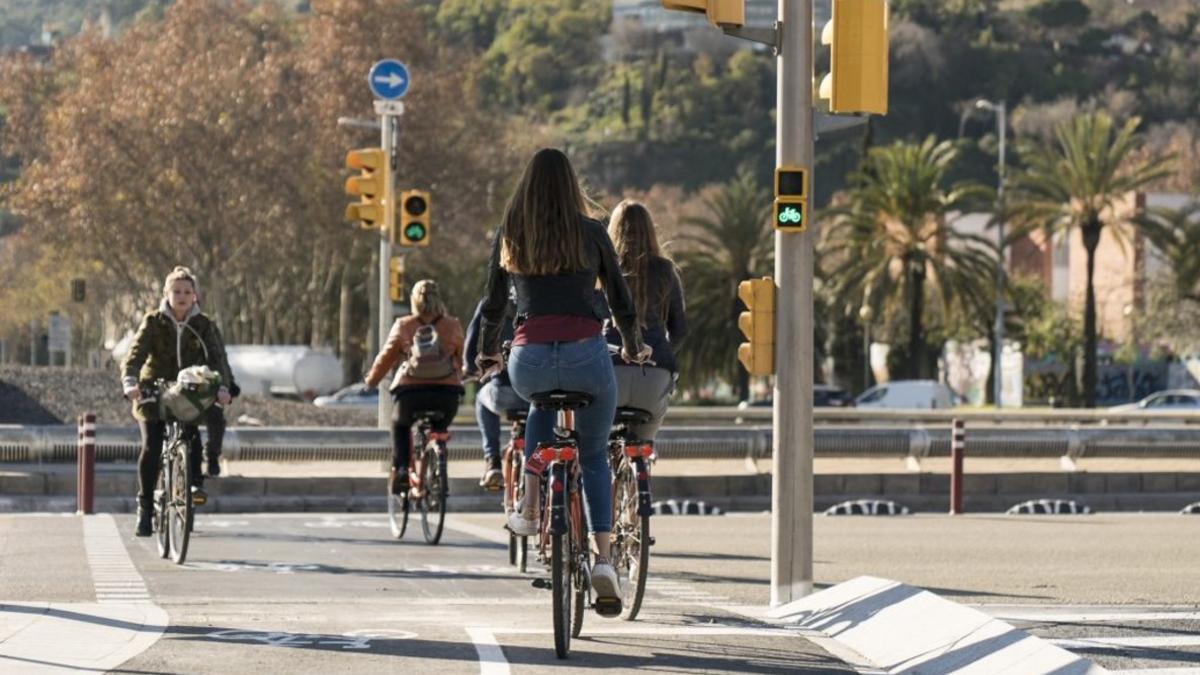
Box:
[768, 577, 1105, 675]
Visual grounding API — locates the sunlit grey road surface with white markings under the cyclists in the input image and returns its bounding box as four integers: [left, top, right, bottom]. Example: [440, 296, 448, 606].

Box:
[0, 506, 1200, 675]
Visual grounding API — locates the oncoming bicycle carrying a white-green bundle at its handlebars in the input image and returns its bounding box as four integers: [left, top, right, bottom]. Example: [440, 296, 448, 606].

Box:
[142, 380, 208, 565]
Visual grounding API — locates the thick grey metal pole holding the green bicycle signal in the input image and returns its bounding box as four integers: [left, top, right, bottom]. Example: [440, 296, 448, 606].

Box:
[770, 0, 815, 605]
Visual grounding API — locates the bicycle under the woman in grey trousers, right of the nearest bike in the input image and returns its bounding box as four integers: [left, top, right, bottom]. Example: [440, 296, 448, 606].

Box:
[608, 407, 655, 621]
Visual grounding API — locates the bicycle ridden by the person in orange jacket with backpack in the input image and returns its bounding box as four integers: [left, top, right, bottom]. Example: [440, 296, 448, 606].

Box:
[388, 411, 450, 545]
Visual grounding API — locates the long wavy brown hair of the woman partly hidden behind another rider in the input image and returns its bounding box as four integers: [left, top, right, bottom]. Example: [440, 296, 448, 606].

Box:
[608, 199, 673, 325]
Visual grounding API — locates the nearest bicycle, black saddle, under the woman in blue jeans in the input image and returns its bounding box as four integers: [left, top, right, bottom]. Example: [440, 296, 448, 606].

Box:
[522, 390, 620, 658]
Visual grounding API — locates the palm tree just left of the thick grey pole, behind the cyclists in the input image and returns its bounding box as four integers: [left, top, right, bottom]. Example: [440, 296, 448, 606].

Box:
[677, 172, 772, 400]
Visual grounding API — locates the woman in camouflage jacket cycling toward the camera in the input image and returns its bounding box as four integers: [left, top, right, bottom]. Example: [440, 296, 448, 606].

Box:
[121, 267, 233, 537]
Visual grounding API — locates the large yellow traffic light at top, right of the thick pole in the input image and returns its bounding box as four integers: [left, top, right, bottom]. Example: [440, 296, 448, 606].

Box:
[818, 0, 888, 115]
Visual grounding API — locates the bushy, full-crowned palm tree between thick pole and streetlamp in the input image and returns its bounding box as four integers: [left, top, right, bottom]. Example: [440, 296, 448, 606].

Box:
[822, 136, 996, 377]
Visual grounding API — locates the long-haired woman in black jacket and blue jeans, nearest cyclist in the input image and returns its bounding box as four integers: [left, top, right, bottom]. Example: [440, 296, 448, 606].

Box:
[479, 149, 650, 608]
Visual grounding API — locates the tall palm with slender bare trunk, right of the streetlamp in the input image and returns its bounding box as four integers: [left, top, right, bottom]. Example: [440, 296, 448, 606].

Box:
[1013, 112, 1170, 407]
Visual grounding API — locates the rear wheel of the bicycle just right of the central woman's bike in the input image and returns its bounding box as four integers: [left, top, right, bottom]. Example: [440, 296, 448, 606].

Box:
[612, 462, 650, 621]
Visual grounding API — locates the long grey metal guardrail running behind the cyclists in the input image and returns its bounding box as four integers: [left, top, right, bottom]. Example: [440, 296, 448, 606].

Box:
[0, 423, 1200, 461]
